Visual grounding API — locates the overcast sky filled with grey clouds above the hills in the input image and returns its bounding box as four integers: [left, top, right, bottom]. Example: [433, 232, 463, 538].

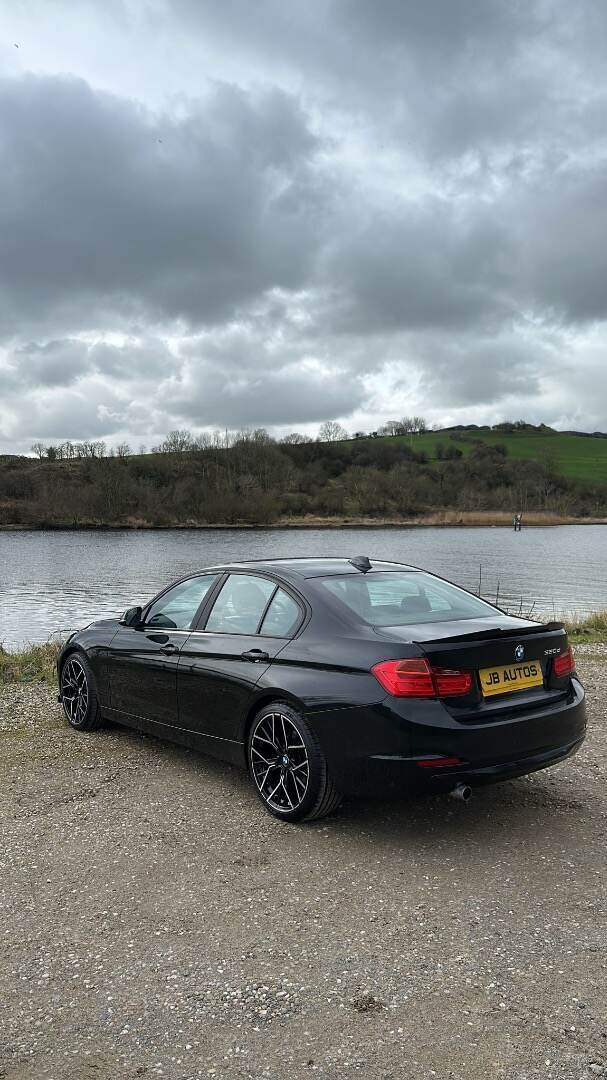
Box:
[0, 0, 607, 453]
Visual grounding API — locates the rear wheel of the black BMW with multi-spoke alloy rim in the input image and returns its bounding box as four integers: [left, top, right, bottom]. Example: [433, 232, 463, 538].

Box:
[247, 702, 341, 821]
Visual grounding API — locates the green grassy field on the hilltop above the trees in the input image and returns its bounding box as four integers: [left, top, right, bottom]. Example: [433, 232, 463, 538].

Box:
[371, 428, 607, 484]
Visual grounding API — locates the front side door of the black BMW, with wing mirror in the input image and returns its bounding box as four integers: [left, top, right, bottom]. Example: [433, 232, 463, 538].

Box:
[108, 573, 219, 725]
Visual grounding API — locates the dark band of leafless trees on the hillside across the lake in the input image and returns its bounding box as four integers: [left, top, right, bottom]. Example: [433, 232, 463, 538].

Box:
[0, 429, 607, 526]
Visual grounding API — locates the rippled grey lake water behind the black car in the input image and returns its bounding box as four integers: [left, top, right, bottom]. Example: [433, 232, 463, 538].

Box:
[0, 525, 607, 648]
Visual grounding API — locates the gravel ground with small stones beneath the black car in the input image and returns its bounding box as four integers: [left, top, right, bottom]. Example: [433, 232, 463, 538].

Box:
[0, 647, 607, 1080]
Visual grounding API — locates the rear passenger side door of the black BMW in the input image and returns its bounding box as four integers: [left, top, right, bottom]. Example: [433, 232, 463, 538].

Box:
[178, 572, 304, 753]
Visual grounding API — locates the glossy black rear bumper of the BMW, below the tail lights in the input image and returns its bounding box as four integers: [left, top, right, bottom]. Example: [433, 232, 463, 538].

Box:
[314, 678, 586, 796]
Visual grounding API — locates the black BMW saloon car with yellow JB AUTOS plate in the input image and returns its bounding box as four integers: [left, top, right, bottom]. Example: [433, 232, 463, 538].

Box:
[57, 555, 585, 822]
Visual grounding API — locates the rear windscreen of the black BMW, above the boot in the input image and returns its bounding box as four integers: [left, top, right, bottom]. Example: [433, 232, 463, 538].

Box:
[319, 570, 496, 626]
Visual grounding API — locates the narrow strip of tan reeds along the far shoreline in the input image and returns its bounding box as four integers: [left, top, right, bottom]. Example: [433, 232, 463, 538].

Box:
[0, 511, 607, 532]
